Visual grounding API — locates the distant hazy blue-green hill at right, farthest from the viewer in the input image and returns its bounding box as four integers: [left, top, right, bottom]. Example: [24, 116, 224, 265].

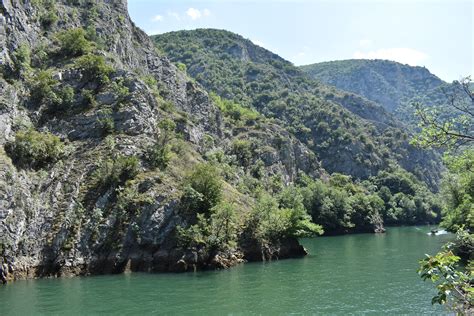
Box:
[300, 59, 448, 113]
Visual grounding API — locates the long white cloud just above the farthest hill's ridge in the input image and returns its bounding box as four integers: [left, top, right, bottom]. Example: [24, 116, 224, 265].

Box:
[353, 47, 429, 66]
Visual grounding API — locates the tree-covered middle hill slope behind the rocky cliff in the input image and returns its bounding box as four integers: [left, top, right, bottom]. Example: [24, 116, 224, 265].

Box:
[152, 29, 440, 187]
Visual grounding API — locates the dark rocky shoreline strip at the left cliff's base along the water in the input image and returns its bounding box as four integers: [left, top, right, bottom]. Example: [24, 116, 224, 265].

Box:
[0, 238, 308, 284]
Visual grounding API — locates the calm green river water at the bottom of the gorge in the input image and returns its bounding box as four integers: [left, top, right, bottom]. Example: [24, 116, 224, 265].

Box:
[0, 227, 452, 315]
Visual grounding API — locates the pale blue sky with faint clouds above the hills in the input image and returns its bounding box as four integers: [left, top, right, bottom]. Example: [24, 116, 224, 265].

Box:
[128, 0, 474, 82]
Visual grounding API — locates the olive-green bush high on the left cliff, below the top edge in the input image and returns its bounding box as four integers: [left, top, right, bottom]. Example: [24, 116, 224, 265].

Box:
[57, 28, 93, 57]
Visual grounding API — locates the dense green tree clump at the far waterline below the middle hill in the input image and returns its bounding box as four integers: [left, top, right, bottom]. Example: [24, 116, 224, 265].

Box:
[300, 169, 441, 233]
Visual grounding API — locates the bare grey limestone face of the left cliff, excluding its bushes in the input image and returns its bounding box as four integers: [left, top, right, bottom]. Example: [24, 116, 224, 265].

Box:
[0, 0, 324, 279]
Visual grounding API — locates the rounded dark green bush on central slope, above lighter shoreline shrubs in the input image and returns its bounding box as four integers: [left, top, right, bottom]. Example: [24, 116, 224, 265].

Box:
[182, 163, 222, 214]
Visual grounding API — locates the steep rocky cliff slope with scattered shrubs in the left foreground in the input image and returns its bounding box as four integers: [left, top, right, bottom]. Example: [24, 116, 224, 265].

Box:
[0, 0, 324, 279]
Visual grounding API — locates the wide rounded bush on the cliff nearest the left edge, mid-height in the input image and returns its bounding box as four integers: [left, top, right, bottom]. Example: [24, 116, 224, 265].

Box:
[6, 129, 64, 169]
